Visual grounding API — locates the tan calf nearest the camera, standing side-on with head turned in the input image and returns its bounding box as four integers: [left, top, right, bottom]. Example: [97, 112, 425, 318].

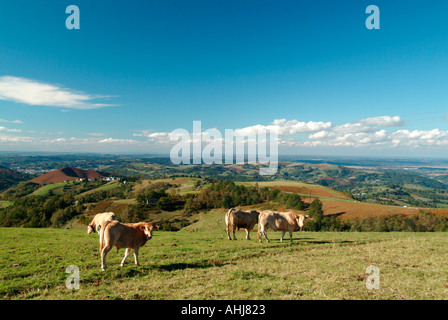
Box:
[100, 221, 159, 271]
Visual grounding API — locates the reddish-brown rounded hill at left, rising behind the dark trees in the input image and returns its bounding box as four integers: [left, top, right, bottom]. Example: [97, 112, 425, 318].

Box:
[30, 167, 107, 184]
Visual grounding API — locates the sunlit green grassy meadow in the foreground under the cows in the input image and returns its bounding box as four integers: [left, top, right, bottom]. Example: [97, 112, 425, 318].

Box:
[0, 212, 448, 300]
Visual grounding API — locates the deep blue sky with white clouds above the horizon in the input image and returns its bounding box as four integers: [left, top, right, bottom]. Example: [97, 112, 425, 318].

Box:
[0, 0, 448, 157]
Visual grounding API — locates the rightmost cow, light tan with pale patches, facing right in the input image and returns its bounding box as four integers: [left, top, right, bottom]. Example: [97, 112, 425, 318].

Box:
[258, 210, 309, 243]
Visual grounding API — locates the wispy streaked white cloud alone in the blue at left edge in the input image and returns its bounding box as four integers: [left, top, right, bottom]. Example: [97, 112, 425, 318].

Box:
[0, 76, 117, 110]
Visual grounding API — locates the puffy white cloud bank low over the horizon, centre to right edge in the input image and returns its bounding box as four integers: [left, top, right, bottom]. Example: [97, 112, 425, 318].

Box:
[134, 116, 448, 148]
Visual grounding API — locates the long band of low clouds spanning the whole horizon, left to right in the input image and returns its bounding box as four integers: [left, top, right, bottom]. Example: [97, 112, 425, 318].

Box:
[0, 116, 448, 152]
